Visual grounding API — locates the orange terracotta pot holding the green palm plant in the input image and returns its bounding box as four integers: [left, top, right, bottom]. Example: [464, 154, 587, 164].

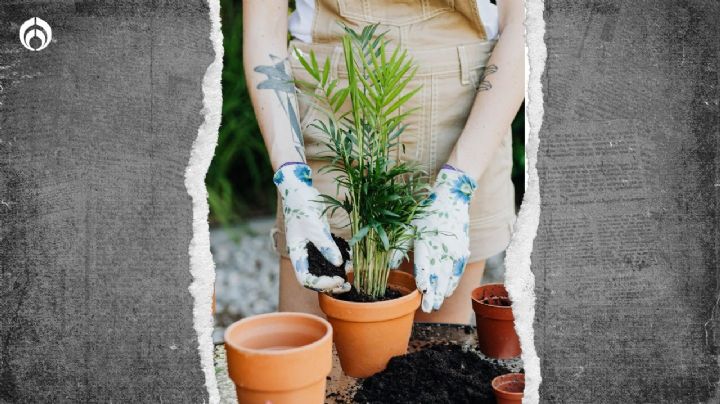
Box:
[318, 271, 420, 377]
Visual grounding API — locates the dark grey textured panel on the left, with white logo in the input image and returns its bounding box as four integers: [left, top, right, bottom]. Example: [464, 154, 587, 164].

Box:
[0, 0, 214, 403]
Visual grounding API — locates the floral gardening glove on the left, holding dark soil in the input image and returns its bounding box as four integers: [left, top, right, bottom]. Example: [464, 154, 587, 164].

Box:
[273, 163, 350, 293]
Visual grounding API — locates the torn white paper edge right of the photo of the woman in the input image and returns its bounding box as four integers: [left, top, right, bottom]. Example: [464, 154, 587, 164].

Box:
[505, 0, 547, 404]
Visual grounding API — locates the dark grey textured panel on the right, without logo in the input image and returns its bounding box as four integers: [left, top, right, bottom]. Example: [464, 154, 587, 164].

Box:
[532, 0, 720, 403]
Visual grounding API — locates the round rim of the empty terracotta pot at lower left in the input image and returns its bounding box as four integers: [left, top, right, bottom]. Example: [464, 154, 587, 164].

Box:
[223, 312, 332, 356]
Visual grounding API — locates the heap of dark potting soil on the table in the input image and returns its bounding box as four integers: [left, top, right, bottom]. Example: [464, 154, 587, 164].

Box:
[354, 345, 511, 404]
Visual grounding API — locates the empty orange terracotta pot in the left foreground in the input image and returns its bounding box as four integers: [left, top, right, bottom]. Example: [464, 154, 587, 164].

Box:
[225, 313, 332, 404]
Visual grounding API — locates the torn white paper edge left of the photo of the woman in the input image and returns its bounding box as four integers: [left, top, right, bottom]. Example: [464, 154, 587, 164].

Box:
[185, 0, 223, 404]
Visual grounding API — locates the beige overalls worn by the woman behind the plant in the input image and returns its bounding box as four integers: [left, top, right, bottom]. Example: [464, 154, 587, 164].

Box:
[274, 0, 515, 262]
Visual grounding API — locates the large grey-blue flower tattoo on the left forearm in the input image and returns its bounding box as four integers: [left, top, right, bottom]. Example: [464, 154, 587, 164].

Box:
[254, 55, 305, 162]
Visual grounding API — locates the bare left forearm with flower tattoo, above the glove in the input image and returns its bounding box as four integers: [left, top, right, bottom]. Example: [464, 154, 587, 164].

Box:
[243, 0, 305, 169]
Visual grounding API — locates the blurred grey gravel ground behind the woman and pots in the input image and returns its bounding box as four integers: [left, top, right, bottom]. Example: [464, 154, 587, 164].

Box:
[210, 217, 504, 342]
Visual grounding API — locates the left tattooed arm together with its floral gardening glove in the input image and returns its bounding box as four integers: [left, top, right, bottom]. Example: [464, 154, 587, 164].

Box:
[243, 0, 350, 293]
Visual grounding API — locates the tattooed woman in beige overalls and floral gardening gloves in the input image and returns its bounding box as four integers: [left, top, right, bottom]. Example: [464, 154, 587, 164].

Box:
[243, 0, 524, 324]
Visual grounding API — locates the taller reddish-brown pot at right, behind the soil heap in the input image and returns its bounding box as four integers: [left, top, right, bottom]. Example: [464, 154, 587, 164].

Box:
[472, 283, 521, 359]
